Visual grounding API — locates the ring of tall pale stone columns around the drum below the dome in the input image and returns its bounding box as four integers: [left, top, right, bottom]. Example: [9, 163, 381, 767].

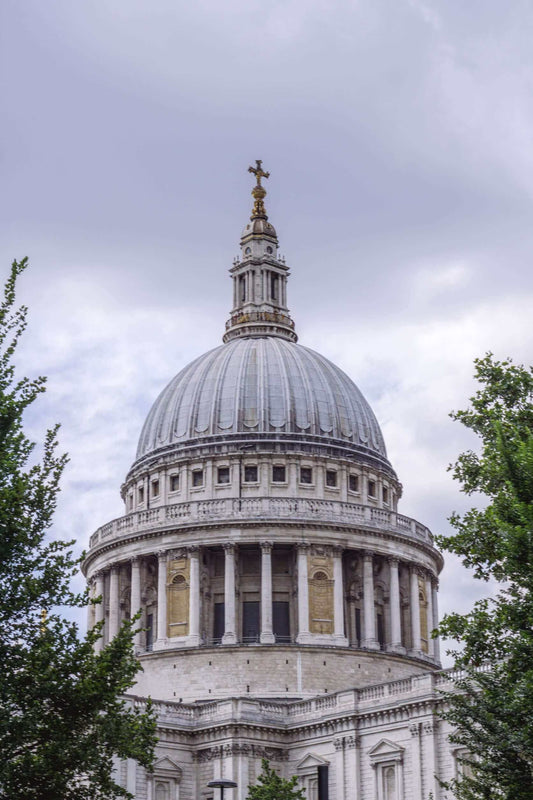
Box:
[88, 541, 439, 661]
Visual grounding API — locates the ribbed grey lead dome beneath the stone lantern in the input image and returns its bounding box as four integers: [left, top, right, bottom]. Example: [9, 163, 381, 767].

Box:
[137, 336, 386, 460]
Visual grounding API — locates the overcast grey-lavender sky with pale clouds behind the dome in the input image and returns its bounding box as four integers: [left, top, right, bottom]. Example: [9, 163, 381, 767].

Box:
[0, 0, 533, 664]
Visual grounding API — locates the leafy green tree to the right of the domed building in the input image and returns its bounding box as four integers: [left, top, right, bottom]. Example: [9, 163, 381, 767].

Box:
[438, 353, 533, 800]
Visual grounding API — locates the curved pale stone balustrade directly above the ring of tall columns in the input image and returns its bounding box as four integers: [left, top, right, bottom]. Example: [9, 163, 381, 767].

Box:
[90, 497, 433, 547]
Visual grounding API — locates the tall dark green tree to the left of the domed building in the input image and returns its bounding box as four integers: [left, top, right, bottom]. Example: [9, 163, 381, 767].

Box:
[0, 259, 155, 800]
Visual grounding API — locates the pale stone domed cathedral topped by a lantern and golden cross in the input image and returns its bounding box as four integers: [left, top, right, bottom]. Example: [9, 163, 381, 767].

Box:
[84, 161, 460, 800]
